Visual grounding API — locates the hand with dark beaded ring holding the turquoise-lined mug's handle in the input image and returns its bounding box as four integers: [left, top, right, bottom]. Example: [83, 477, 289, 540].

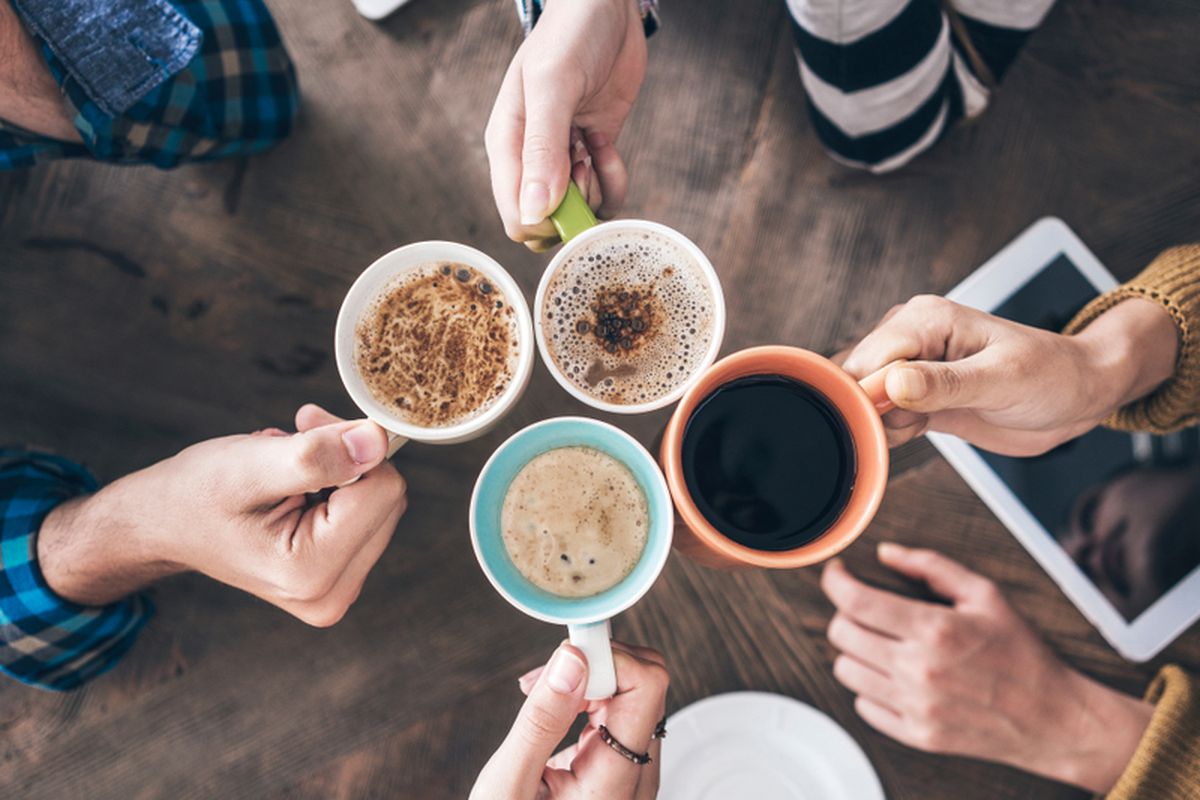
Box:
[470, 642, 670, 800]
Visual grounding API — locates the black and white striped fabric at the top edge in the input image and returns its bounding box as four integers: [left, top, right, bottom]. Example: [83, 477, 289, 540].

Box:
[787, 0, 1054, 173]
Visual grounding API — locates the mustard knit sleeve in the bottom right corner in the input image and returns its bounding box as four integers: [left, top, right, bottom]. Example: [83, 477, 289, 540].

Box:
[1106, 666, 1200, 800]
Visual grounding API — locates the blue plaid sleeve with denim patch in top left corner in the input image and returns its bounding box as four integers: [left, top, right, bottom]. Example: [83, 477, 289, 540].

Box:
[0, 0, 300, 169]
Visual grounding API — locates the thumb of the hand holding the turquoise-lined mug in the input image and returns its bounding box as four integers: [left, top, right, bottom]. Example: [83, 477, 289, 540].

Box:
[475, 644, 588, 798]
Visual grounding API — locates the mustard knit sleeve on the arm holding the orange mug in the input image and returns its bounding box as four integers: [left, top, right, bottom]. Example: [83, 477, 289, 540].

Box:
[1063, 243, 1200, 433]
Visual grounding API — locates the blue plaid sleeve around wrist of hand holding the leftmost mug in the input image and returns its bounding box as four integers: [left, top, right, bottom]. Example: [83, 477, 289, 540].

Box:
[0, 450, 154, 691]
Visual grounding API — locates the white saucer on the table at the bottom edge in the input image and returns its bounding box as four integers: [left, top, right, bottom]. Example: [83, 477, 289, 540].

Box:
[659, 692, 886, 800]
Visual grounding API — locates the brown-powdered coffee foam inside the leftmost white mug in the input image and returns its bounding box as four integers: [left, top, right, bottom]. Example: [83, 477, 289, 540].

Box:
[354, 261, 520, 428]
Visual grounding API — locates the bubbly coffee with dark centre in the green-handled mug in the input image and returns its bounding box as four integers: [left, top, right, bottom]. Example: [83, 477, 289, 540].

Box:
[539, 226, 714, 405]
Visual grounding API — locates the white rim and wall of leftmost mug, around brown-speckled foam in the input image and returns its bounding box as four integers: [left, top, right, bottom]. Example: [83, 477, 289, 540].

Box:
[334, 241, 533, 457]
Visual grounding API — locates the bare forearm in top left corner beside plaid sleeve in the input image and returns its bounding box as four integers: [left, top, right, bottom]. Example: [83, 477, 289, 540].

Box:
[0, 0, 80, 142]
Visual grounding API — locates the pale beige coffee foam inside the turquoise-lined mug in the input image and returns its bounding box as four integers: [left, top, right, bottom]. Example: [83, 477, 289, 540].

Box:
[500, 446, 649, 597]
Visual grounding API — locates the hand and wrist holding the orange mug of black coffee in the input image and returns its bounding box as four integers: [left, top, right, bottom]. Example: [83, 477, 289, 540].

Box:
[842, 295, 1178, 456]
